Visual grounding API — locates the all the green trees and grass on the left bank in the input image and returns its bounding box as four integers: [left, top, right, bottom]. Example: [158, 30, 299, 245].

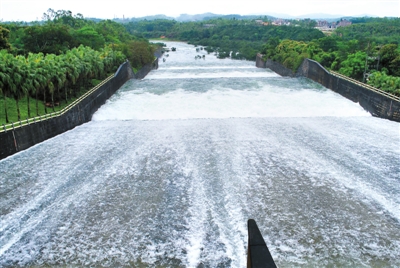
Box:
[0, 9, 157, 124]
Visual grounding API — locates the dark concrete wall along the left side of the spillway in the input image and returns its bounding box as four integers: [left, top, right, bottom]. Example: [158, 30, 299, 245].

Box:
[0, 60, 158, 160]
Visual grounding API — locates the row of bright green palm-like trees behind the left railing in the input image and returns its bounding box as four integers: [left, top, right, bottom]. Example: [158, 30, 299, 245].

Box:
[0, 45, 125, 123]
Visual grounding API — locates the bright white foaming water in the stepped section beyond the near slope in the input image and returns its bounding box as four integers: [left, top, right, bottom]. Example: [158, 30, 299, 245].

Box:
[93, 52, 370, 121]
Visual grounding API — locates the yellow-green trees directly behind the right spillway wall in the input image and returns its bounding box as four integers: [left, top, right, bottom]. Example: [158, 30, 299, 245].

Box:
[261, 19, 400, 96]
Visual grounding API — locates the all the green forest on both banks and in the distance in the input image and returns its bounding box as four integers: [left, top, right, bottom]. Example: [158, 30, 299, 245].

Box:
[0, 13, 400, 123]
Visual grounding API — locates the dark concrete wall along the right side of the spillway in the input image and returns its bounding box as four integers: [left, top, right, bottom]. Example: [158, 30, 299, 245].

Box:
[256, 54, 400, 122]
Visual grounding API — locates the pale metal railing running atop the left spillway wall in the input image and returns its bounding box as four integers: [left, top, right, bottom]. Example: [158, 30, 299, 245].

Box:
[0, 74, 115, 132]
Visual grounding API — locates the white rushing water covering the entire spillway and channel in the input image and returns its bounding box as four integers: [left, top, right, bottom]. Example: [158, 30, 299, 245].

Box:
[0, 40, 400, 267]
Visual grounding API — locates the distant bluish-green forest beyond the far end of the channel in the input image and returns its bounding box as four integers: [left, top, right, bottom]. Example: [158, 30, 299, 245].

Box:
[125, 17, 324, 60]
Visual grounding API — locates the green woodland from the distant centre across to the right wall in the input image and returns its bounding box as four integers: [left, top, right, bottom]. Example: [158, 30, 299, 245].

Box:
[130, 16, 400, 95]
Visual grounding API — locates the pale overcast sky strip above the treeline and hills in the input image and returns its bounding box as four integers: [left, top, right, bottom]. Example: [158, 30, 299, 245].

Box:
[0, 0, 400, 21]
